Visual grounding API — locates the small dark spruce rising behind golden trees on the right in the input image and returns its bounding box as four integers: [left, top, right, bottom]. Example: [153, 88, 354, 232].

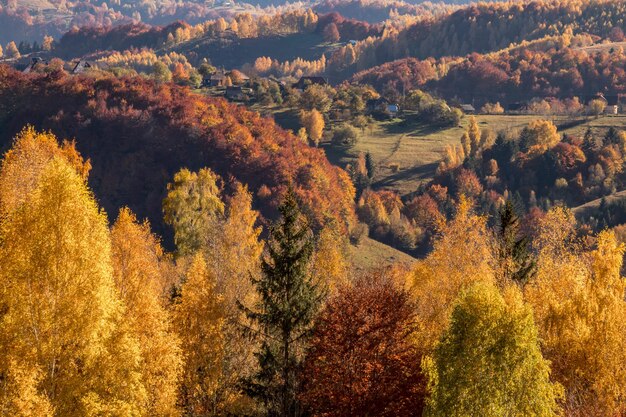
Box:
[496, 200, 536, 285]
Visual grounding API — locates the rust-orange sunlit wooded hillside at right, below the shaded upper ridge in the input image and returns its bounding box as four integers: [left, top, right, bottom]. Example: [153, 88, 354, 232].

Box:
[352, 31, 626, 105]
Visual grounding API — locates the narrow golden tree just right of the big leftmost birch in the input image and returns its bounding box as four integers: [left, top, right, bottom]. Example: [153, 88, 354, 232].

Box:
[111, 208, 182, 416]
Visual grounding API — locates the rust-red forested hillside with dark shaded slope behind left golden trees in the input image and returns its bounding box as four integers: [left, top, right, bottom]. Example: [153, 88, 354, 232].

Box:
[0, 66, 353, 240]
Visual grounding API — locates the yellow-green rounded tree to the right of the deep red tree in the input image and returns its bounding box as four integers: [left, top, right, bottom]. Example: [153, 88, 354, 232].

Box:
[425, 283, 562, 417]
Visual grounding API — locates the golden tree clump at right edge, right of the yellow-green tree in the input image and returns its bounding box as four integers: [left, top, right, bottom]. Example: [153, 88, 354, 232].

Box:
[525, 208, 626, 416]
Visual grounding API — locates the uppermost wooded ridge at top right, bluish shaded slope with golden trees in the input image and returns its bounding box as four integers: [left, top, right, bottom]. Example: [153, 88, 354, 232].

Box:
[328, 0, 626, 78]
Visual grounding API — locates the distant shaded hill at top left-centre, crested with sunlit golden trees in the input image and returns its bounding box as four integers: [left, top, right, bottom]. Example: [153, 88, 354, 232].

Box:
[53, 9, 381, 68]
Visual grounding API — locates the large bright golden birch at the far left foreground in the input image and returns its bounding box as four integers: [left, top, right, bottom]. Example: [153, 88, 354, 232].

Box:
[0, 157, 146, 416]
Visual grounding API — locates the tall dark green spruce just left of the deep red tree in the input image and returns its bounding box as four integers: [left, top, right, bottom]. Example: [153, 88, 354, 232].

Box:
[241, 190, 323, 417]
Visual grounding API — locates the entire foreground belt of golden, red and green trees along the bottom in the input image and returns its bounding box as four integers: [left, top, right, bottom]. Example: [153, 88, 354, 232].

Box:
[0, 124, 626, 416]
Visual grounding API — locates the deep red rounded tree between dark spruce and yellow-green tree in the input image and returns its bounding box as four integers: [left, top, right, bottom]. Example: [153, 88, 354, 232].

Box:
[302, 272, 425, 417]
